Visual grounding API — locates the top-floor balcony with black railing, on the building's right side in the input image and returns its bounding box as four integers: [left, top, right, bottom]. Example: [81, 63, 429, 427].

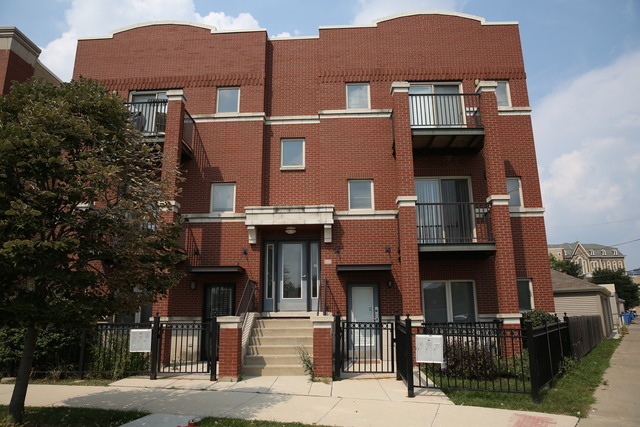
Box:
[409, 93, 484, 154]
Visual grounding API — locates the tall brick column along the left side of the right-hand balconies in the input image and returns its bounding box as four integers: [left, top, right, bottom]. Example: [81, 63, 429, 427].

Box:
[391, 82, 422, 316]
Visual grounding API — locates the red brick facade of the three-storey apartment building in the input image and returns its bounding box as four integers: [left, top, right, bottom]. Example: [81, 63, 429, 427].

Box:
[74, 13, 554, 368]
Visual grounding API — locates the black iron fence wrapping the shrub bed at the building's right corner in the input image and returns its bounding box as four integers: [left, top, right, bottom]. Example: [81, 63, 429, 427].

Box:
[395, 316, 604, 400]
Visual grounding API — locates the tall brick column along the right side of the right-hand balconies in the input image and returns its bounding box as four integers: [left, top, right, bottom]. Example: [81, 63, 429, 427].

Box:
[476, 81, 521, 325]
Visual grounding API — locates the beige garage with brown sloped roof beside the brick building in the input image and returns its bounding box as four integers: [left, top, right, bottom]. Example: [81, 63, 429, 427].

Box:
[551, 270, 614, 337]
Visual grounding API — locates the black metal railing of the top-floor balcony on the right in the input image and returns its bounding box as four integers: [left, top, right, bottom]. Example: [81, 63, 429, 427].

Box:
[409, 93, 483, 129]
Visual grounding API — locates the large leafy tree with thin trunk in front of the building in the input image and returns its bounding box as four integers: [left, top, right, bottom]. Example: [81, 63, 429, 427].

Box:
[0, 79, 182, 422]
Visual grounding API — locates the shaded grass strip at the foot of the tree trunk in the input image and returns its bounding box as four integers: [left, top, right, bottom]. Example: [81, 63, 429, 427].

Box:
[0, 405, 148, 427]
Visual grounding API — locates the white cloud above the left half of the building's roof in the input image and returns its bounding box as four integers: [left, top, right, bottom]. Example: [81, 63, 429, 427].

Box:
[40, 0, 259, 81]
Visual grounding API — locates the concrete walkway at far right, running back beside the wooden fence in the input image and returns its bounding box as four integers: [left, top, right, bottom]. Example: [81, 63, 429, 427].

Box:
[579, 318, 640, 427]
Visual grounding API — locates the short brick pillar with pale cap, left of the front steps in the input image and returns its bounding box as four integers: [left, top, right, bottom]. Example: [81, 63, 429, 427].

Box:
[218, 316, 242, 381]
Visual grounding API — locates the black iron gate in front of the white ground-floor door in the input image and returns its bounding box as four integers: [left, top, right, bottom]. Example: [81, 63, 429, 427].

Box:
[334, 316, 395, 376]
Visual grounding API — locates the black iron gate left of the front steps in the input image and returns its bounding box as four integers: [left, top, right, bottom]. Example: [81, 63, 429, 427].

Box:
[151, 317, 218, 380]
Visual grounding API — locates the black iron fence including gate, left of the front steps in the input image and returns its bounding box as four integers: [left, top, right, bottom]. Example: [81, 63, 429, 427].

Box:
[0, 317, 219, 380]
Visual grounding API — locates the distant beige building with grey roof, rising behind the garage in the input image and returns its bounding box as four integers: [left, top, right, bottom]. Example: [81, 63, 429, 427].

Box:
[547, 242, 626, 277]
